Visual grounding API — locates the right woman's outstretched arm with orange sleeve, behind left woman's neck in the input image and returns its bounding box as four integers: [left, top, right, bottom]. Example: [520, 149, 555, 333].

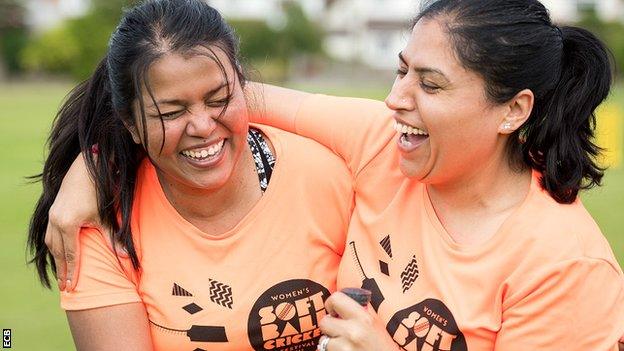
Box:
[248, 83, 396, 178]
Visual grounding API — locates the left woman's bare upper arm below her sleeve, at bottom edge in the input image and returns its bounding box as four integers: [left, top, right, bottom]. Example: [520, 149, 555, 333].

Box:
[67, 302, 152, 351]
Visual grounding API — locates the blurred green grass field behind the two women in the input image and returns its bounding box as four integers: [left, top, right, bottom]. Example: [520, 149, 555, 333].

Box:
[0, 83, 624, 351]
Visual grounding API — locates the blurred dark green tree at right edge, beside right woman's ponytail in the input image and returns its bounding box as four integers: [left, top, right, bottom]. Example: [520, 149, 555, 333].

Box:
[577, 7, 624, 77]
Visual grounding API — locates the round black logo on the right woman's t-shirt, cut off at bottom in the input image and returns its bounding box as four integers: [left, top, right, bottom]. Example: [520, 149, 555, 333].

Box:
[386, 299, 468, 351]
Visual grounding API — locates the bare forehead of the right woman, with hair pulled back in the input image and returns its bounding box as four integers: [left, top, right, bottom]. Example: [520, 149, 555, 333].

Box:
[402, 18, 461, 73]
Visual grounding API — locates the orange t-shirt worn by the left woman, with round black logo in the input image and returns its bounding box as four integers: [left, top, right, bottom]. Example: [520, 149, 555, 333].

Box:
[61, 126, 353, 351]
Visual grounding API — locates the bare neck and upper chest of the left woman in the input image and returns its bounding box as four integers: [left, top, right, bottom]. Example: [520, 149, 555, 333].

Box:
[158, 148, 262, 235]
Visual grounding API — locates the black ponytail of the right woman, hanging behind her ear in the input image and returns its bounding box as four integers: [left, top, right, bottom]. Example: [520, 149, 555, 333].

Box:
[521, 27, 612, 203]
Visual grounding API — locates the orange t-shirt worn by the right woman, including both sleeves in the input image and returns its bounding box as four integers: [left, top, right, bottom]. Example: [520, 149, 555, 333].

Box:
[291, 95, 624, 351]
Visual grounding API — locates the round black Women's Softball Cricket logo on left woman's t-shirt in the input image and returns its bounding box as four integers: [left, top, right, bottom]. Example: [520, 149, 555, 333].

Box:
[247, 279, 329, 351]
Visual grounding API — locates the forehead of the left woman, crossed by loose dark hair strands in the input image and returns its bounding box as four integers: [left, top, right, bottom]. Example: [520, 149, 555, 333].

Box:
[147, 47, 233, 95]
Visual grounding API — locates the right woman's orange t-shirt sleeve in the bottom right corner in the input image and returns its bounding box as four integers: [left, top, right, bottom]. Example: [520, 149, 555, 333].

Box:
[495, 258, 624, 351]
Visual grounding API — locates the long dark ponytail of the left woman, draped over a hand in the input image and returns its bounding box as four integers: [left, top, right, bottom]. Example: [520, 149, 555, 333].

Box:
[28, 58, 142, 288]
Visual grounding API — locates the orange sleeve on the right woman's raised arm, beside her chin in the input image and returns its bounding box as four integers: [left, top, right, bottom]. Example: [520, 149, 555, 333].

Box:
[294, 94, 395, 178]
